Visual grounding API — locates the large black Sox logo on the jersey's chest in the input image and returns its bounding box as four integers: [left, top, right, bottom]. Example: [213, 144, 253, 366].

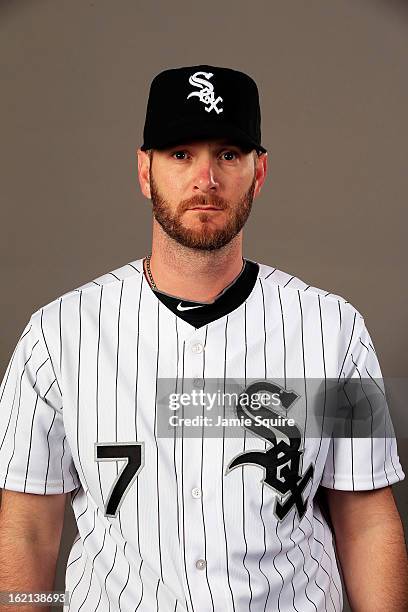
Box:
[226, 380, 314, 520]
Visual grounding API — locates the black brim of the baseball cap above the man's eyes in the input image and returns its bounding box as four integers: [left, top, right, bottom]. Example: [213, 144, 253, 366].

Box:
[141, 120, 267, 153]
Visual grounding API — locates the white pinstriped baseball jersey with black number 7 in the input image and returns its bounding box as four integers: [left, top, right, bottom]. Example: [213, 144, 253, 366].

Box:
[0, 259, 404, 612]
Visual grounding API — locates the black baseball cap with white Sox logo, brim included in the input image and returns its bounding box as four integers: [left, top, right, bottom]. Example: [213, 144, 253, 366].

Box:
[141, 64, 266, 153]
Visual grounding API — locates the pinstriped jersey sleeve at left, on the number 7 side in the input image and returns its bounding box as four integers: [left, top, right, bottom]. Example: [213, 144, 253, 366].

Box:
[0, 313, 79, 495]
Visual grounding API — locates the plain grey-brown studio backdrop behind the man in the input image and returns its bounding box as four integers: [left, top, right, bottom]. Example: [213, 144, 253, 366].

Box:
[0, 0, 408, 610]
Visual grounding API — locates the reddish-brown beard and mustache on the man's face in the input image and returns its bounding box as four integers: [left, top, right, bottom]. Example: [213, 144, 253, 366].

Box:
[150, 173, 256, 251]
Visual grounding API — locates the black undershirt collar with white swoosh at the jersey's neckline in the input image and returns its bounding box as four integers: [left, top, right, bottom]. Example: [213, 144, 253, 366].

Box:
[149, 259, 259, 328]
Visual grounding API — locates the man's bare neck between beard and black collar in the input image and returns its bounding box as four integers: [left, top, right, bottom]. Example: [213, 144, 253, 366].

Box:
[146, 227, 243, 302]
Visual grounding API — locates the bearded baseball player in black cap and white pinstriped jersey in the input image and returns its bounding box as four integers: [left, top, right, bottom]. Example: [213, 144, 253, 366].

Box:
[0, 65, 407, 612]
